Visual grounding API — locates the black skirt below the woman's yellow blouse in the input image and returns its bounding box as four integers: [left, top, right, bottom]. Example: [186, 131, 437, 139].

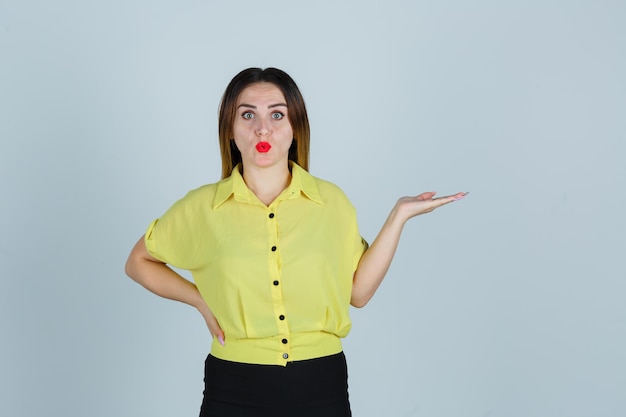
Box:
[200, 352, 352, 417]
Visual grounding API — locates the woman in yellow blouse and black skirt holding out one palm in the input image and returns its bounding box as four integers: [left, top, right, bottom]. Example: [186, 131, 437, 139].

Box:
[126, 68, 465, 417]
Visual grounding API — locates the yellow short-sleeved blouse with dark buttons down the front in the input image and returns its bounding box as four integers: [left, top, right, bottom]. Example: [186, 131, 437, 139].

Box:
[145, 163, 367, 365]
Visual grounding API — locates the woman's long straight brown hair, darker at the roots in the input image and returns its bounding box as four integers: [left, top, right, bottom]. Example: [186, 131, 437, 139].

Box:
[218, 68, 311, 178]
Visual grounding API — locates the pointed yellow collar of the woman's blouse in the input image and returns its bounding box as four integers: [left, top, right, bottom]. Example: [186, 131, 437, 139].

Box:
[213, 161, 323, 210]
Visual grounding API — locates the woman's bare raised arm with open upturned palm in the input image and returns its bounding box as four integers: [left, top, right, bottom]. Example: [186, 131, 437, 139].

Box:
[350, 192, 467, 307]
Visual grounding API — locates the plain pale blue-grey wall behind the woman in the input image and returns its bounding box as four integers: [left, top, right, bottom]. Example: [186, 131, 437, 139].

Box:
[0, 0, 626, 417]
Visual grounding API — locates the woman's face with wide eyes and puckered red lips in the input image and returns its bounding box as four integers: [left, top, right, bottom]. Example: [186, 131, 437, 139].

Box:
[233, 82, 293, 170]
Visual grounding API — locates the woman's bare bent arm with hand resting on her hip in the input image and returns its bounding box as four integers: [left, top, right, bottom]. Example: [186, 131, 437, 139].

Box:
[126, 236, 224, 344]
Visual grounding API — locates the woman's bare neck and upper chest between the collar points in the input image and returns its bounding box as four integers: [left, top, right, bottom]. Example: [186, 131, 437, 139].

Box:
[243, 165, 291, 206]
